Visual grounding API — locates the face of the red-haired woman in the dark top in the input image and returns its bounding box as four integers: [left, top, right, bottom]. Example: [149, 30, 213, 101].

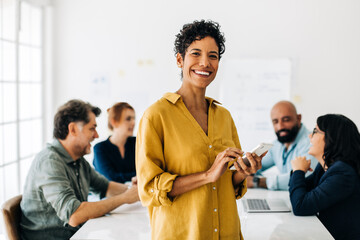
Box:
[113, 108, 135, 137]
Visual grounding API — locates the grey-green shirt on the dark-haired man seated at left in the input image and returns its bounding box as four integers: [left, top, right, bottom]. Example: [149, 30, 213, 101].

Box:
[20, 140, 109, 239]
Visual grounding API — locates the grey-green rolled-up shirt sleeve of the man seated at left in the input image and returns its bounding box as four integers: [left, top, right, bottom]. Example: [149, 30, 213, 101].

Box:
[38, 157, 81, 223]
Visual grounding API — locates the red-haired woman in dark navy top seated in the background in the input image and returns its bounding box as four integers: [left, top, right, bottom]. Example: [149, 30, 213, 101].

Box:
[93, 102, 136, 183]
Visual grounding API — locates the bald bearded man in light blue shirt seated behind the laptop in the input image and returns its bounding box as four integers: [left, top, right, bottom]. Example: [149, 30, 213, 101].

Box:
[247, 101, 317, 190]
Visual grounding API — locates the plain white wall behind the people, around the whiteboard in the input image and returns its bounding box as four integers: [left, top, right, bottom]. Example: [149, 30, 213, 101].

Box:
[51, 0, 360, 156]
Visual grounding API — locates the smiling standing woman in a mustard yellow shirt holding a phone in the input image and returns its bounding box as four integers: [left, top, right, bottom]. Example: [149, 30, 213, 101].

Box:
[136, 20, 263, 240]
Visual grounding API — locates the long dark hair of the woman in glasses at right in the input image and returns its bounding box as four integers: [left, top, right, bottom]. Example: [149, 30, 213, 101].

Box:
[316, 114, 360, 175]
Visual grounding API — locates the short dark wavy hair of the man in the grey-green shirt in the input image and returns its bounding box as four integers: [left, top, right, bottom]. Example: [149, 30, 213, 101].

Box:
[53, 99, 101, 140]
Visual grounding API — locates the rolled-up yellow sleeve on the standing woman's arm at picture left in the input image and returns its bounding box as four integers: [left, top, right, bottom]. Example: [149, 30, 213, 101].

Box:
[136, 116, 177, 207]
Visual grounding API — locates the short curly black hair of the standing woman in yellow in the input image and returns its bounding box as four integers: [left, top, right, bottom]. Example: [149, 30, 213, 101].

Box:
[174, 20, 225, 59]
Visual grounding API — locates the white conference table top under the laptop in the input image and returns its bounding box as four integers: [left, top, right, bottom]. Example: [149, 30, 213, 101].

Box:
[71, 189, 333, 240]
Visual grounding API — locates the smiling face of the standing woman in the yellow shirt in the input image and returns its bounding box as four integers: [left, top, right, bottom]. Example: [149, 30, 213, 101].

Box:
[176, 37, 219, 88]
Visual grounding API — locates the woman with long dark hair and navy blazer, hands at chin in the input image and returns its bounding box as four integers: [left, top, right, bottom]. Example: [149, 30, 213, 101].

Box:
[289, 114, 360, 239]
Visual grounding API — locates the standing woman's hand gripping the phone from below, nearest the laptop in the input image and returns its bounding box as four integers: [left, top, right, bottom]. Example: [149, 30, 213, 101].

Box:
[234, 152, 267, 175]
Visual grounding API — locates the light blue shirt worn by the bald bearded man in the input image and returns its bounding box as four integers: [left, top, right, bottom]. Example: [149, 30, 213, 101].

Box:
[257, 124, 318, 190]
